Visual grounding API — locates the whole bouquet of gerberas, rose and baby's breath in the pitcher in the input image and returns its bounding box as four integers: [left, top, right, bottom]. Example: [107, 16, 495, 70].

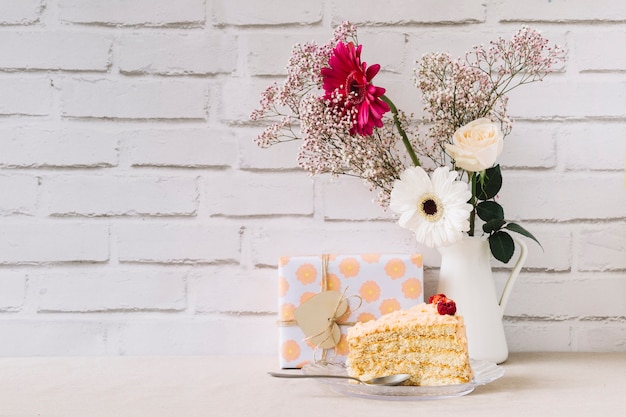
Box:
[251, 22, 564, 263]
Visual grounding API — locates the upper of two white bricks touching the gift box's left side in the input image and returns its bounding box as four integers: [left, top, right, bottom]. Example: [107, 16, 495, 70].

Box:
[188, 265, 277, 313]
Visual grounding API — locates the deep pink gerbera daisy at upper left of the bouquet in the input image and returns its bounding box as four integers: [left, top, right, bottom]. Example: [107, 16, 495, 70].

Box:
[322, 42, 389, 136]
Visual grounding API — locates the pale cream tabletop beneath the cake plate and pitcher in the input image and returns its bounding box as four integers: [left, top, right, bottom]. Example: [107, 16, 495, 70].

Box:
[0, 352, 626, 417]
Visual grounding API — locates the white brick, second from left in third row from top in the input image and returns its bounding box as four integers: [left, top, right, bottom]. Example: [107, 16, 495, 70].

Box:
[60, 79, 206, 120]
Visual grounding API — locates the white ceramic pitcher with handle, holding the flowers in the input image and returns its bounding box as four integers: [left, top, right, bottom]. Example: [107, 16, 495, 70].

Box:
[437, 237, 527, 363]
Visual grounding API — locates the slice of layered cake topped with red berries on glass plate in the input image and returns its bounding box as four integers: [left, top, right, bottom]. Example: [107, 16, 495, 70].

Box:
[347, 294, 472, 386]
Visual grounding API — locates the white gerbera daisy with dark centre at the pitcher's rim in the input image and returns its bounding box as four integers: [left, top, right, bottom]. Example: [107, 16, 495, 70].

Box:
[389, 167, 472, 248]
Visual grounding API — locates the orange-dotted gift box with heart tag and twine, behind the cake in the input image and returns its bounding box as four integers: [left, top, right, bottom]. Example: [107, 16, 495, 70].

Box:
[278, 254, 424, 369]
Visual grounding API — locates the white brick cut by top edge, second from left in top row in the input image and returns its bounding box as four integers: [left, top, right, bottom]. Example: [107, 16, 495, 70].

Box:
[58, 0, 205, 26]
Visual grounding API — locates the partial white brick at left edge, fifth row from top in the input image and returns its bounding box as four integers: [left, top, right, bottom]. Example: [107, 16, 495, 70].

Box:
[0, 175, 39, 215]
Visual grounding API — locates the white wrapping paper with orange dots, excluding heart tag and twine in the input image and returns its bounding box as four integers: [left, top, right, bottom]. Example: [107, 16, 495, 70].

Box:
[278, 253, 424, 369]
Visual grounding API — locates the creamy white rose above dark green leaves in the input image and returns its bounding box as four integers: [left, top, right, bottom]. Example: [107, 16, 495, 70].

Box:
[446, 117, 504, 172]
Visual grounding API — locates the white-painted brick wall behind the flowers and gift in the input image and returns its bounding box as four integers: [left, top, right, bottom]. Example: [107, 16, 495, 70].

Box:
[0, 0, 626, 355]
